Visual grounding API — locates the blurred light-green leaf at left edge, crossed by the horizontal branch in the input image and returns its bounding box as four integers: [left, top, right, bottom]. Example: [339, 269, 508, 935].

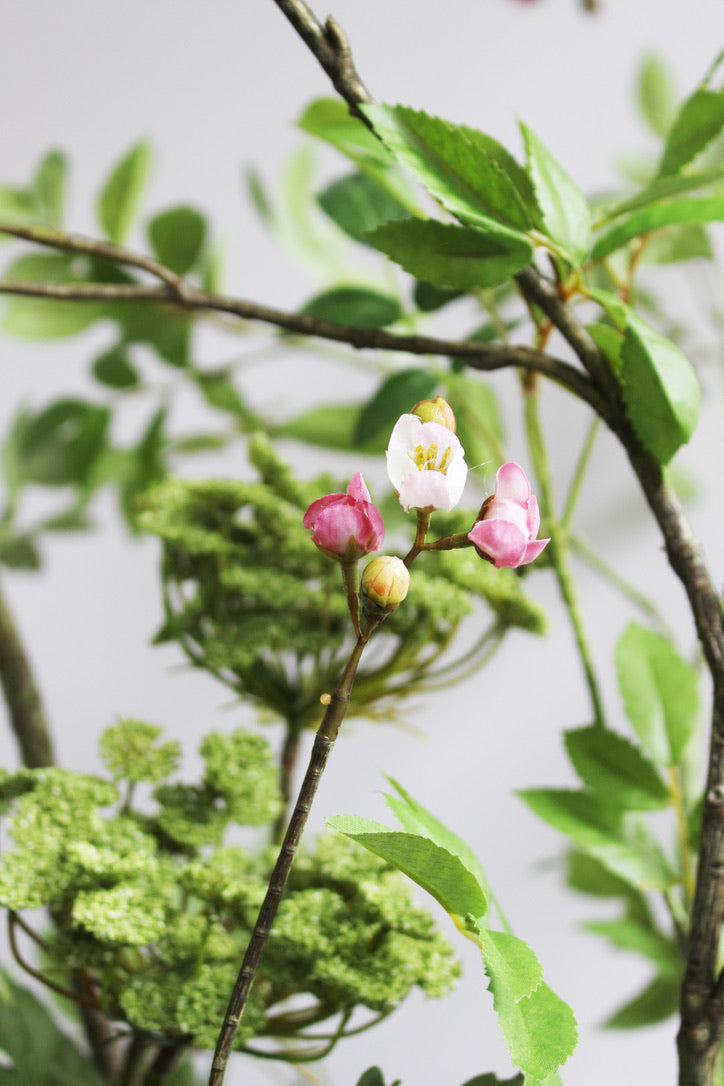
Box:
[0, 253, 103, 340]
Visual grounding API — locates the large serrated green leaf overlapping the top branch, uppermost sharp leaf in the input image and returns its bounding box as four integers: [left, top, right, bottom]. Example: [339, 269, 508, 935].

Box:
[363, 105, 533, 230]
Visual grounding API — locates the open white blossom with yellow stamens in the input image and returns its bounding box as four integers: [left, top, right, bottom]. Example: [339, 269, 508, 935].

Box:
[388, 414, 468, 510]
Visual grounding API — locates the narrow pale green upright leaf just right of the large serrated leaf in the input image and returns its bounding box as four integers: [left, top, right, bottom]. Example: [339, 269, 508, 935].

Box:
[520, 124, 590, 264]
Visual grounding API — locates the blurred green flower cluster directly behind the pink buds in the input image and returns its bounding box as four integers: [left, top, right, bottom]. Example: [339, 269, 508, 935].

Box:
[139, 435, 545, 733]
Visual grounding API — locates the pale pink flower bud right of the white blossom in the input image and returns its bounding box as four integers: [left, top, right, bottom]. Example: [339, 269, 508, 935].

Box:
[468, 463, 550, 569]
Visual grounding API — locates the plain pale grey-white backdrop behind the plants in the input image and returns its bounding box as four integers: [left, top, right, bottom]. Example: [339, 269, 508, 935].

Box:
[0, 0, 724, 1086]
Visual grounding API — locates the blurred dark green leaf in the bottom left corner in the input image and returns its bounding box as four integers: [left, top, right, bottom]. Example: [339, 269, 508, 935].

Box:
[0, 972, 103, 1086]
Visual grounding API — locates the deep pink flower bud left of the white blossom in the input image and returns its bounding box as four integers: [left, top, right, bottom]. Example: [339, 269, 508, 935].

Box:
[304, 471, 384, 561]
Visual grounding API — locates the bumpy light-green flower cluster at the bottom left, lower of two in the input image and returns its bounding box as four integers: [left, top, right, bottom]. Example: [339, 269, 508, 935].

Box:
[0, 720, 458, 1060]
